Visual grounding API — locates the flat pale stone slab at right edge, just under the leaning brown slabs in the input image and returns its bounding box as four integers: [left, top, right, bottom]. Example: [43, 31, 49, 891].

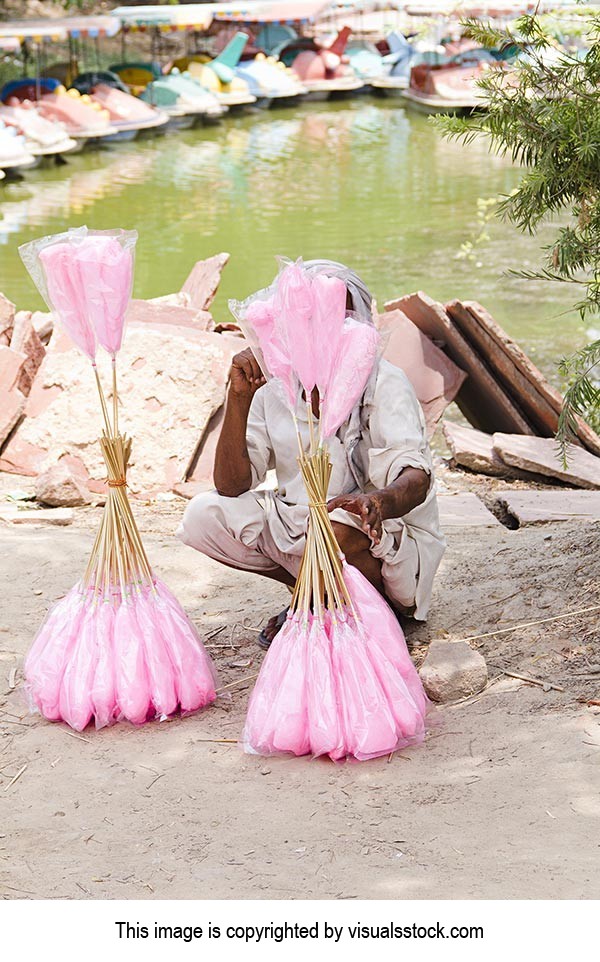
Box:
[494, 433, 600, 488]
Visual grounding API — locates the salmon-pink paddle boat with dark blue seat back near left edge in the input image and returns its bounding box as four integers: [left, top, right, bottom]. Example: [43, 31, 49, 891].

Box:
[0, 77, 117, 147]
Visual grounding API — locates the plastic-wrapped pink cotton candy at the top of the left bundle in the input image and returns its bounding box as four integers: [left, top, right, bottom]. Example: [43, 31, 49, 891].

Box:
[19, 227, 137, 360]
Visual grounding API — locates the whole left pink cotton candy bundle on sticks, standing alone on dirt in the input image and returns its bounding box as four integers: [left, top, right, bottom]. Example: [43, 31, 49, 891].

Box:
[21, 228, 216, 731]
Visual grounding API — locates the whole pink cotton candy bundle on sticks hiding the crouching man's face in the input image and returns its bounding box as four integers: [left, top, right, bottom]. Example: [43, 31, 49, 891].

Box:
[232, 255, 427, 761]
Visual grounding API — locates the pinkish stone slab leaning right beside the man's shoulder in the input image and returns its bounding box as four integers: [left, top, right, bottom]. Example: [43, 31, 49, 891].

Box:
[378, 310, 467, 437]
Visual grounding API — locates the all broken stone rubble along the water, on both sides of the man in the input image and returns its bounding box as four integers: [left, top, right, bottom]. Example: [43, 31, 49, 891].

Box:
[0, 254, 600, 512]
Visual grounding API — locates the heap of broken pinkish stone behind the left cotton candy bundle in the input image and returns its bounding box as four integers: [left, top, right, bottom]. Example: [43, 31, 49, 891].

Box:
[0, 254, 240, 505]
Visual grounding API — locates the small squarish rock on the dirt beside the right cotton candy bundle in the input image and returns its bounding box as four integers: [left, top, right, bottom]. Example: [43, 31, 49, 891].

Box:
[419, 641, 488, 702]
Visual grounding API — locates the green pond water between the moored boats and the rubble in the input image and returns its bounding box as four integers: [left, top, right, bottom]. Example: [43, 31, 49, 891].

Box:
[0, 99, 586, 380]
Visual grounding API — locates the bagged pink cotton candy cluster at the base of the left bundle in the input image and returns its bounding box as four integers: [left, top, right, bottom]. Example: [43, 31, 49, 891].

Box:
[25, 580, 216, 731]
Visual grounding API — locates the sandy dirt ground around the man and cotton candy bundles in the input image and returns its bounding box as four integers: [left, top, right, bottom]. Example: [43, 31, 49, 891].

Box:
[0, 468, 600, 899]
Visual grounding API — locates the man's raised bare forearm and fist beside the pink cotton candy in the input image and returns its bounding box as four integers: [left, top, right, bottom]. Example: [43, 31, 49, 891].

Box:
[214, 348, 265, 498]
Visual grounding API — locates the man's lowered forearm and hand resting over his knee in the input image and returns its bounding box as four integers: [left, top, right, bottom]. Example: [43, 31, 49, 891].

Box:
[327, 467, 430, 544]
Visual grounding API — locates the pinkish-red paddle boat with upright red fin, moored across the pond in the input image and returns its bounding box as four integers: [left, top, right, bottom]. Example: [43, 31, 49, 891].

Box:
[277, 27, 364, 100]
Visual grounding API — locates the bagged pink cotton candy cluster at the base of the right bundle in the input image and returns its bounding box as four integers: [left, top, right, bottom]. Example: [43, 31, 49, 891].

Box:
[242, 564, 428, 761]
